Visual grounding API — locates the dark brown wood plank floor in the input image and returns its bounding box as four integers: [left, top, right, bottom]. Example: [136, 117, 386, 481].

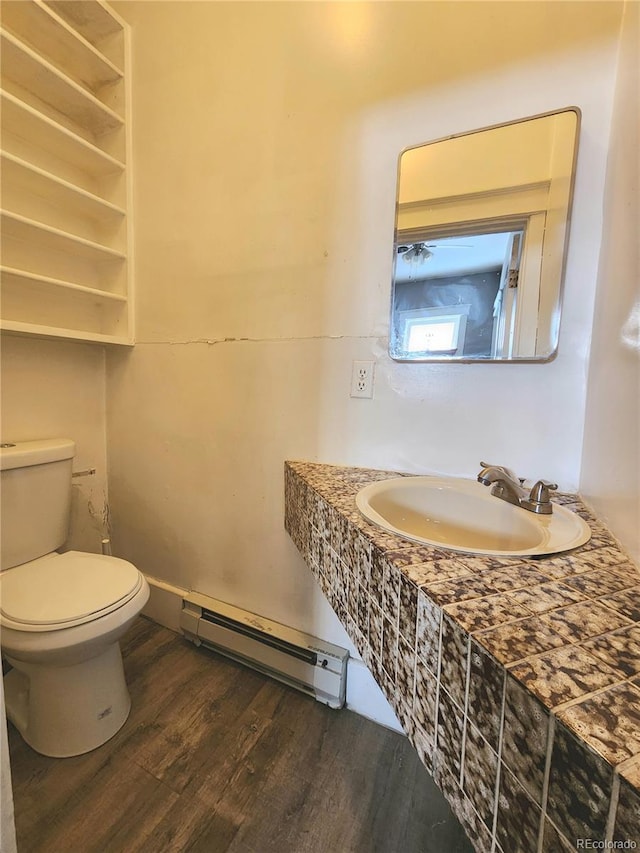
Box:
[9, 617, 472, 853]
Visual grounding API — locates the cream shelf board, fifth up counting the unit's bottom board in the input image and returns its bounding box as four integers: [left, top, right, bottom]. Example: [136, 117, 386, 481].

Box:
[0, 90, 125, 177]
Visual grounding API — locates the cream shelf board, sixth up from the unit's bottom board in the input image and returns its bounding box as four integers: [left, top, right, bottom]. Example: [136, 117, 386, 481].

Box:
[0, 31, 124, 137]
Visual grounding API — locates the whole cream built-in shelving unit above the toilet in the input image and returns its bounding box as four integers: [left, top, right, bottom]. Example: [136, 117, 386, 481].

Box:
[0, 0, 134, 345]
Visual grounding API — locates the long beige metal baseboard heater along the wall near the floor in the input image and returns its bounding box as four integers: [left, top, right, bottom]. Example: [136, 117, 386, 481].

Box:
[180, 592, 349, 708]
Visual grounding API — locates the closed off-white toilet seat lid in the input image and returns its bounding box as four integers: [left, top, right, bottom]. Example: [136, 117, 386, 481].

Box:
[0, 551, 142, 631]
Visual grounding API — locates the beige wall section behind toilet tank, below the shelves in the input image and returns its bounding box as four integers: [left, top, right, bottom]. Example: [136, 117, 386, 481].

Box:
[0, 335, 107, 552]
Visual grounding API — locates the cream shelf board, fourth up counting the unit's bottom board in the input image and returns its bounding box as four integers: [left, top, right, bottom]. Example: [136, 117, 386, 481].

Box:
[0, 151, 125, 223]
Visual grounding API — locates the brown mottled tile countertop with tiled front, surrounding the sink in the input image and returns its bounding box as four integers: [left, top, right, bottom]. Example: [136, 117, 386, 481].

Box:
[286, 462, 640, 850]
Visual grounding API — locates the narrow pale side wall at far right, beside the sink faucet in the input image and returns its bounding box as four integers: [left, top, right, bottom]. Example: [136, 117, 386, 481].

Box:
[580, 2, 640, 563]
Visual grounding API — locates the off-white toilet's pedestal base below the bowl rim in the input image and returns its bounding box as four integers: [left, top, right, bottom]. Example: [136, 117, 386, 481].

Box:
[4, 642, 131, 758]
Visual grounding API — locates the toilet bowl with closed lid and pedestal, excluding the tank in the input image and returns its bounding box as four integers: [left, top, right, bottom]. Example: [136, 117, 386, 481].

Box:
[0, 551, 149, 758]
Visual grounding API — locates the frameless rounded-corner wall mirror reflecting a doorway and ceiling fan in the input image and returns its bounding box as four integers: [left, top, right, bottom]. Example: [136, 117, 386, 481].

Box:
[389, 108, 580, 361]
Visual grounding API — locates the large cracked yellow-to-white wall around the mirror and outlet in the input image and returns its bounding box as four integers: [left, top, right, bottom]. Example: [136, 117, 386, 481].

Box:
[108, 0, 620, 660]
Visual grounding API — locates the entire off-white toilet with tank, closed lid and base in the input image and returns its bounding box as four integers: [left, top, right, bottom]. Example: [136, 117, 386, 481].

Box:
[0, 439, 149, 758]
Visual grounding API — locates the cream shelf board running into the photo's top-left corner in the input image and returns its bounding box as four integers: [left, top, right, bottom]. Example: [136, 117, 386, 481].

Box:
[2, 0, 123, 93]
